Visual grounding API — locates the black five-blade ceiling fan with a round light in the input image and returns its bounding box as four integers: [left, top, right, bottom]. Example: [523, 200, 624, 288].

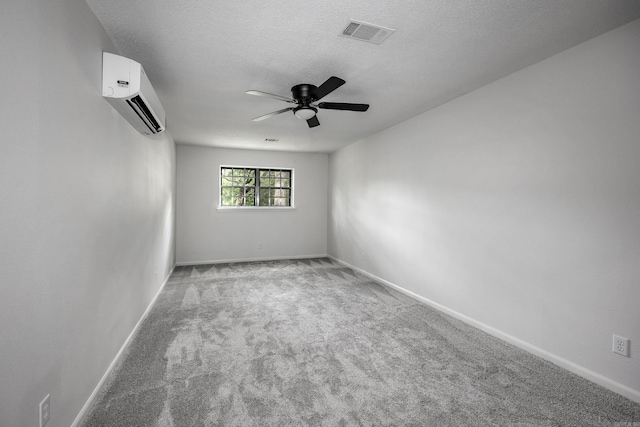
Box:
[247, 76, 369, 128]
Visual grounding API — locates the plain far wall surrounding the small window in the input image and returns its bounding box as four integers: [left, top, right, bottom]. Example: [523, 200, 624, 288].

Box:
[176, 145, 328, 264]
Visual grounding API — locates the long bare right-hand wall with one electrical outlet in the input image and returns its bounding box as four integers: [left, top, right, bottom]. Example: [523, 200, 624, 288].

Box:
[328, 21, 640, 401]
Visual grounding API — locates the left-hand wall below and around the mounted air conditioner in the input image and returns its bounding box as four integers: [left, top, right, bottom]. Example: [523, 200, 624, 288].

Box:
[0, 0, 175, 427]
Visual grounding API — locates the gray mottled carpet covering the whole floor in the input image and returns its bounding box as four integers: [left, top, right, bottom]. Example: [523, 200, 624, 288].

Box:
[83, 258, 640, 427]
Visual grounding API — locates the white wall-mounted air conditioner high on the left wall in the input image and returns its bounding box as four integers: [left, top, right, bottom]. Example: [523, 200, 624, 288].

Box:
[102, 52, 165, 135]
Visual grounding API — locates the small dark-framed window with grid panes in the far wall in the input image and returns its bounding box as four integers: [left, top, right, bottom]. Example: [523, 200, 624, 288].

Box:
[220, 166, 293, 208]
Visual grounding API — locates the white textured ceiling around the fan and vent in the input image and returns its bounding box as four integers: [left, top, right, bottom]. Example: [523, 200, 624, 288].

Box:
[86, 0, 640, 152]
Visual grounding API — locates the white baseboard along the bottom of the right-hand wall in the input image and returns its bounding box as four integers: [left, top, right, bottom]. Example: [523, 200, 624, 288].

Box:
[328, 255, 640, 403]
